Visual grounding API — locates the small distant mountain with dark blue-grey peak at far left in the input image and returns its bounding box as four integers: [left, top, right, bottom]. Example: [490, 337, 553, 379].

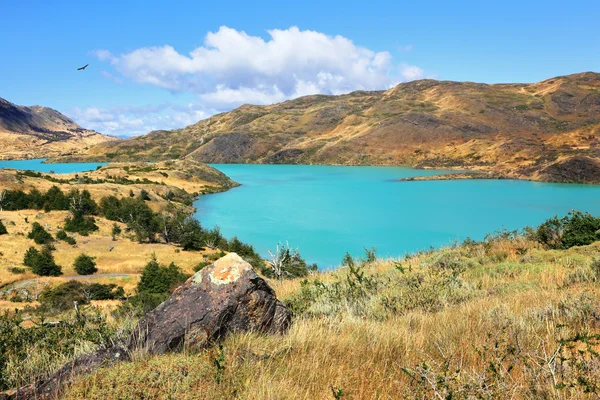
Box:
[0, 98, 116, 159]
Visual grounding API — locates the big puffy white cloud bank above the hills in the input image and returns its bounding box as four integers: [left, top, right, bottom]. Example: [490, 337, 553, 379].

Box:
[83, 26, 425, 135]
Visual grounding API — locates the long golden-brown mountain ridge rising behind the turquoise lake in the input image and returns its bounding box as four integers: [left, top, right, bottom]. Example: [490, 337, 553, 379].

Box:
[54, 72, 600, 183]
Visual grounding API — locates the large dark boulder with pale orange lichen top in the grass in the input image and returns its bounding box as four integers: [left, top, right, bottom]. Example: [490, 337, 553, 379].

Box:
[129, 253, 291, 354]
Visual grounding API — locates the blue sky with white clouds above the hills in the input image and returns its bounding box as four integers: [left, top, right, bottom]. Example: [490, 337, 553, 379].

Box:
[0, 0, 600, 136]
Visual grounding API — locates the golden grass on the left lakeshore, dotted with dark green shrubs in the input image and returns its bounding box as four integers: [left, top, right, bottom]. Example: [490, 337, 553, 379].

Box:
[0, 161, 236, 287]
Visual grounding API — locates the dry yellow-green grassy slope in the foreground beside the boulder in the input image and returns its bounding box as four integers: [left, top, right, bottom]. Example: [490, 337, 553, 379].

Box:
[59, 238, 600, 399]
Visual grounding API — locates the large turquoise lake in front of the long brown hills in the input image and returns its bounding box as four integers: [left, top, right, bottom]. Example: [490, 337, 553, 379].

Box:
[195, 164, 600, 268]
